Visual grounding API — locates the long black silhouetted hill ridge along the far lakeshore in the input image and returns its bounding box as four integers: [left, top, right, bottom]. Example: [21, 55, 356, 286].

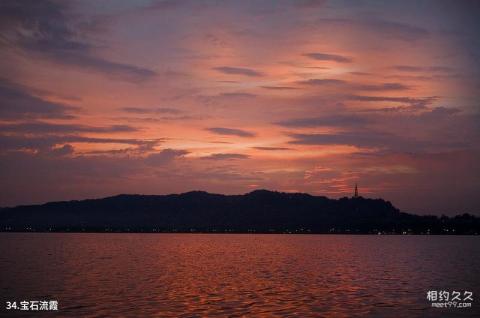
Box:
[0, 190, 480, 234]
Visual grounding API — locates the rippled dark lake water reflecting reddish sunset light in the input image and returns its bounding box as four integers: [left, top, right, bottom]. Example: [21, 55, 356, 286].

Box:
[0, 233, 480, 317]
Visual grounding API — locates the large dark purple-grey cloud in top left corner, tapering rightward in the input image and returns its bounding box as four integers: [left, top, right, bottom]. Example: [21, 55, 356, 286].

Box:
[0, 0, 156, 82]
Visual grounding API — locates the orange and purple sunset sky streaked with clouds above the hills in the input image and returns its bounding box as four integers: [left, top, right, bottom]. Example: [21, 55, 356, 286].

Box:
[0, 0, 480, 215]
